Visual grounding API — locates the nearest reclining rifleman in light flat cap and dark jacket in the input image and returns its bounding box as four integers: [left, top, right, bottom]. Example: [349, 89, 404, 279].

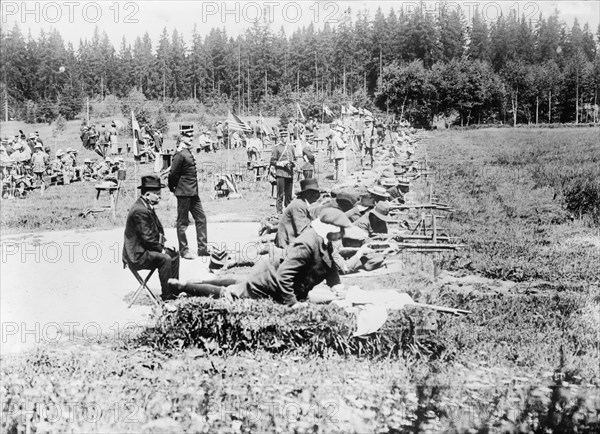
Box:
[170, 208, 351, 306]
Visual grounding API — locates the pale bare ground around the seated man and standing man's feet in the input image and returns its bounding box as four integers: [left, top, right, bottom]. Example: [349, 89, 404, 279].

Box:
[0, 222, 258, 354]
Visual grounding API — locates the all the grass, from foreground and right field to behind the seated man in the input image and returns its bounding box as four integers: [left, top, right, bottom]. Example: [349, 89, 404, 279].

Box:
[0, 122, 600, 433]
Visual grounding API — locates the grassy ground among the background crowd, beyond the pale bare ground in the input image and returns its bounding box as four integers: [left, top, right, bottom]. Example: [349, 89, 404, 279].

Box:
[0, 119, 346, 233]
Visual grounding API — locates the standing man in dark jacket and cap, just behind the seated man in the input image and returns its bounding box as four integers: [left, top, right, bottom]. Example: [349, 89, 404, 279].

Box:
[169, 131, 209, 259]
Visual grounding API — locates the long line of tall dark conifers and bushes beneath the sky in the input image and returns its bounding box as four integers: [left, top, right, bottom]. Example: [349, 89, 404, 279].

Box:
[0, 4, 600, 125]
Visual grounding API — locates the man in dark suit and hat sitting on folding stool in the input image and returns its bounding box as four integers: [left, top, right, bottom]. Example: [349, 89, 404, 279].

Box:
[123, 175, 179, 300]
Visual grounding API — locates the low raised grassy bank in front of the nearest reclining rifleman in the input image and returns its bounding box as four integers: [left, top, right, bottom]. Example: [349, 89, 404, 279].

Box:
[142, 298, 444, 358]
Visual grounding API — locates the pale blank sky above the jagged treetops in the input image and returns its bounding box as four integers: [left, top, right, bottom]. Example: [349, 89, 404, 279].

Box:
[0, 0, 600, 49]
